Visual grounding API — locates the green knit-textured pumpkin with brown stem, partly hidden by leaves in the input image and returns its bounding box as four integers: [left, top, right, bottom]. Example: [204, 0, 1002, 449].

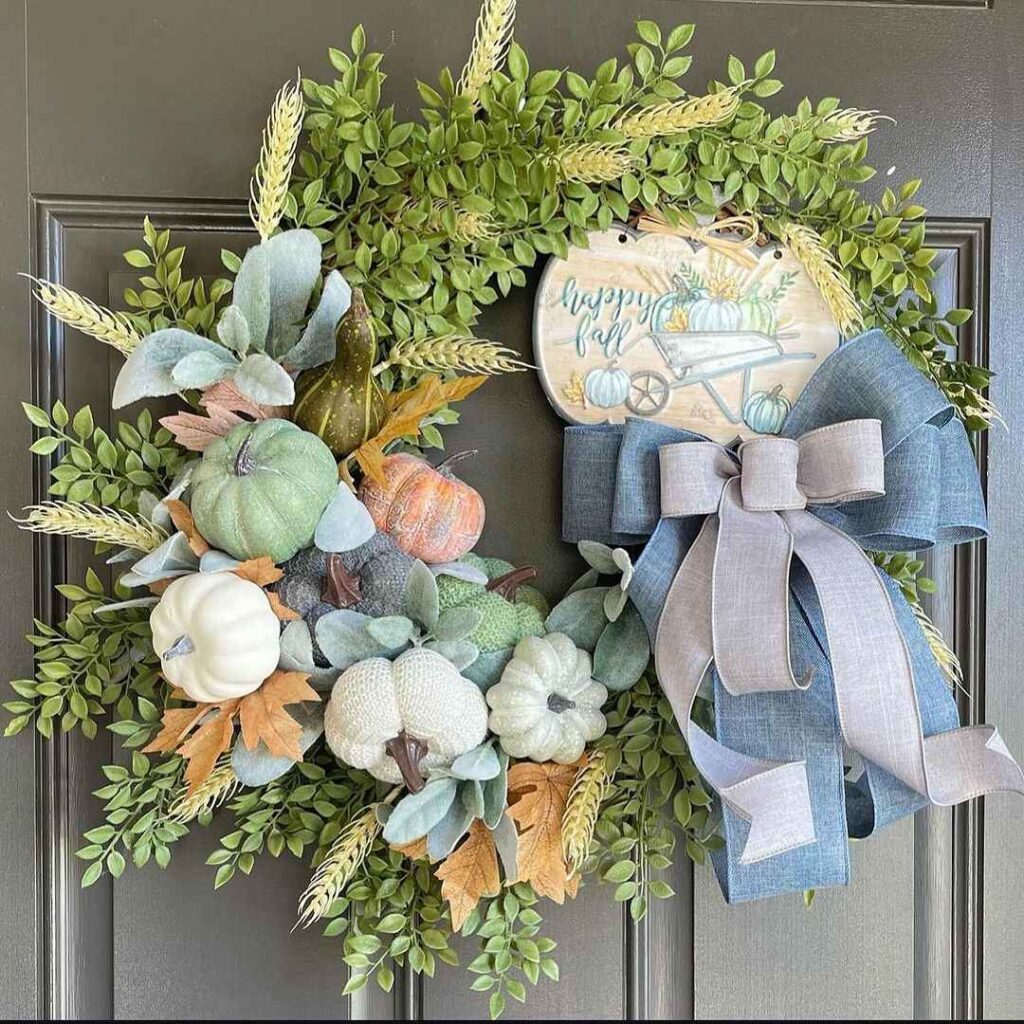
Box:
[437, 554, 549, 653]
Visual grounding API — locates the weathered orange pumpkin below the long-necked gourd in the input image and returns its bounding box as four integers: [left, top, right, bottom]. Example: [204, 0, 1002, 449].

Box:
[359, 452, 483, 563]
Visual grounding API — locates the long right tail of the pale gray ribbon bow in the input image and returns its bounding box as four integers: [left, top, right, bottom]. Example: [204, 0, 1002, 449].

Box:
[782, 512, 1024, 806]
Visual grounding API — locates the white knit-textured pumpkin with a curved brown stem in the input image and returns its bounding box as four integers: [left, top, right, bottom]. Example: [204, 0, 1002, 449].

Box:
[324, 647, 487, 793]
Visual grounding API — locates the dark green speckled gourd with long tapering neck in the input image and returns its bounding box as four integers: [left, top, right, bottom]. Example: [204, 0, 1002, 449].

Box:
[292, 288, 386, 459]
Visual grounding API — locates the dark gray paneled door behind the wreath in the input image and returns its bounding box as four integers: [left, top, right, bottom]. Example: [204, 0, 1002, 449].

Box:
[0, 0, 1024, 1019]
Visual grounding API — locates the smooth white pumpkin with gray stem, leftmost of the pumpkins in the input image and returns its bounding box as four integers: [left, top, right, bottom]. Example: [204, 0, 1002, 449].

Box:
[150, 572, 281, 703]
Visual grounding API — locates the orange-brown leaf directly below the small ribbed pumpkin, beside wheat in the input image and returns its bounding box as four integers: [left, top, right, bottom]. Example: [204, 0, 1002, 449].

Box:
[507, 759, 586, 903]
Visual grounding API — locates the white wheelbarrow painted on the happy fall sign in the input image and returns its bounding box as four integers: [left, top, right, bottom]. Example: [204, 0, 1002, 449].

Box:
[626, 331, 817, 423]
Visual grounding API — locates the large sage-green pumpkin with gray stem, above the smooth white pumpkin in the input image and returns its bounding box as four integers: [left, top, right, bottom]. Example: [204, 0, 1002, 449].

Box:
[191, 420, 338, 562]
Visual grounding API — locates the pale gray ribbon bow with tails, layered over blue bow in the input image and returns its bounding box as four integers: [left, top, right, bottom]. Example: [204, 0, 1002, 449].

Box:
[654, 420, 1024, 863]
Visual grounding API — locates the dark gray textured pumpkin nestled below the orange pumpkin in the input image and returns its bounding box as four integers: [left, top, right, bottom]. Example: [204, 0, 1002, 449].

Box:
[275, 534, 413, 668]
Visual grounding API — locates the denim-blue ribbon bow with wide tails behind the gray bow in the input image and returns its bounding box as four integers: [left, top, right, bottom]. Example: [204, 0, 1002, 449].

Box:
[563, 331, 999, 902]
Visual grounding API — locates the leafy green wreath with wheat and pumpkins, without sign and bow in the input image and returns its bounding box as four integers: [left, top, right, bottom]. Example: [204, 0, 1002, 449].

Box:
[5, 0, 1015, 1016]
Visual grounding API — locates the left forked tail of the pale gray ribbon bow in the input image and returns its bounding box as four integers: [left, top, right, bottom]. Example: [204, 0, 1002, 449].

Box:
[654, 516, 815, 864]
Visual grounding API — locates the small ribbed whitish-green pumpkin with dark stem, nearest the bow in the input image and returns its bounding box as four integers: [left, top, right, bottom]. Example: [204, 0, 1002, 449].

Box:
[487, 633, 608, 764]
